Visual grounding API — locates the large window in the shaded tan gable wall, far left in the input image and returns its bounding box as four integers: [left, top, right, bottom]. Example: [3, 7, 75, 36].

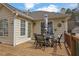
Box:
[0, 19, 8, 36]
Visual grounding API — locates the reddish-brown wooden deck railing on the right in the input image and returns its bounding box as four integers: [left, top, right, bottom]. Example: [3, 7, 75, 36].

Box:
[64, 33, 79, 56]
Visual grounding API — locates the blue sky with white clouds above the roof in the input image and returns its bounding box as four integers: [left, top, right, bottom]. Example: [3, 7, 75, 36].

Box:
[10, 3, 77, 12]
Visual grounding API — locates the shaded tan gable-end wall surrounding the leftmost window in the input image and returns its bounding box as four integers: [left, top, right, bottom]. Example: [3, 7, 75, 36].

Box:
[0, 6, 13, 45]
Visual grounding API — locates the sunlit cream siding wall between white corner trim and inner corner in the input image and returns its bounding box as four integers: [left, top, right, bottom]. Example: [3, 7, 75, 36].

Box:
[14, 17, 31, 46]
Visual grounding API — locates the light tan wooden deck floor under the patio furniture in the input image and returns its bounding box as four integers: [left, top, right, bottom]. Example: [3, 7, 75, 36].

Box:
[0, 41, 68, 56]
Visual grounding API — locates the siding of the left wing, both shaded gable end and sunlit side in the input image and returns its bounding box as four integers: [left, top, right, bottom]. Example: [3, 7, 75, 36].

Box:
[0, 4, 33, 46]
